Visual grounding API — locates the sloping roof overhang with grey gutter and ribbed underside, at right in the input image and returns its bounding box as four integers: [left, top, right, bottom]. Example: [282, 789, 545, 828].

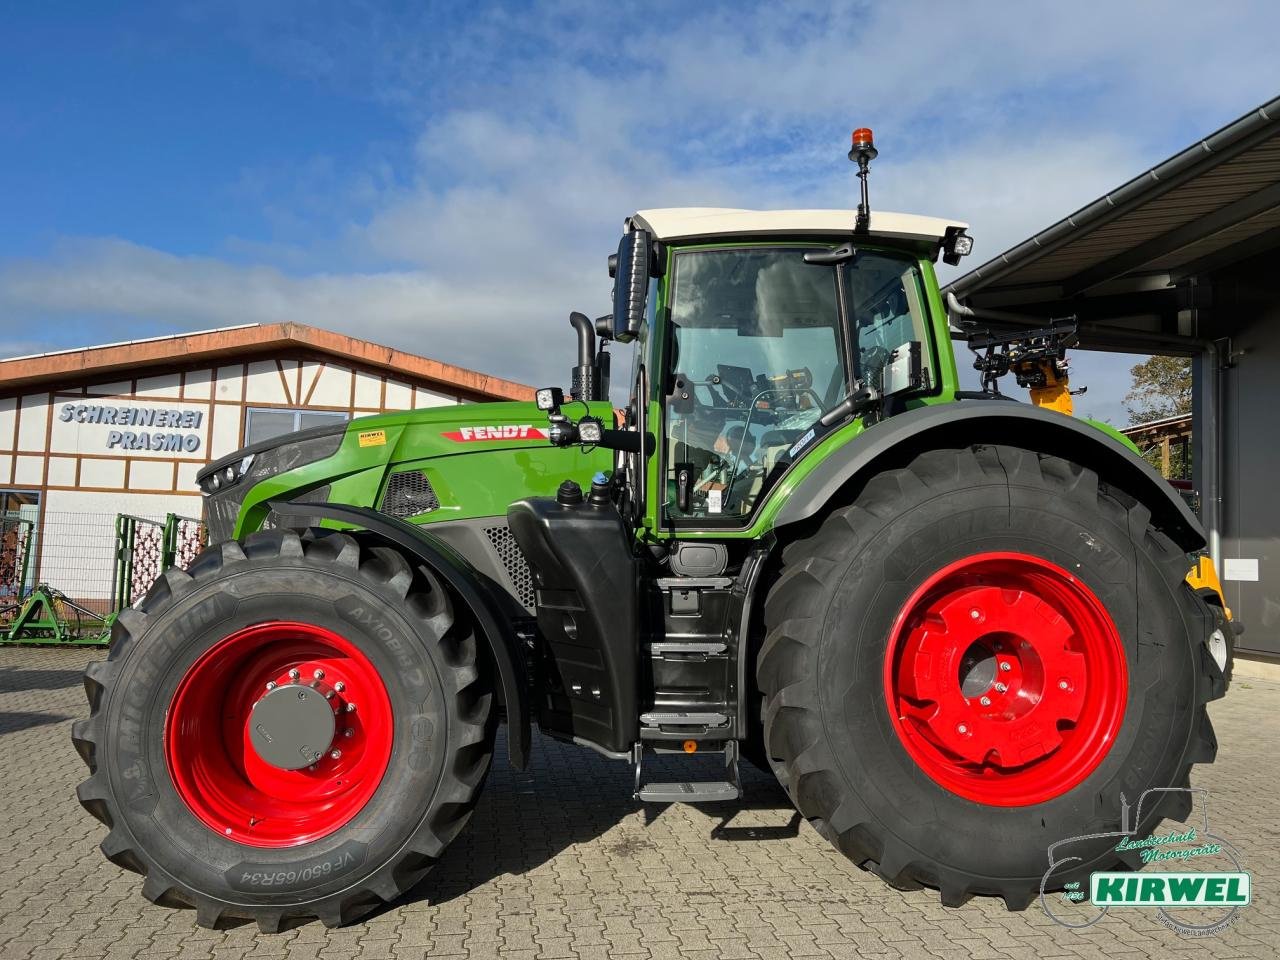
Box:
[946, 97, 1280, 306]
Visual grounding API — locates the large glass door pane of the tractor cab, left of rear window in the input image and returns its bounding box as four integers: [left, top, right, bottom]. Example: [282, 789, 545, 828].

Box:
[666, 247, 846, 518]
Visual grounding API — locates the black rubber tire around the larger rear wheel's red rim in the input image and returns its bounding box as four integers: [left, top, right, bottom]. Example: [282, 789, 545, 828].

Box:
[758, 447, 1225, 909]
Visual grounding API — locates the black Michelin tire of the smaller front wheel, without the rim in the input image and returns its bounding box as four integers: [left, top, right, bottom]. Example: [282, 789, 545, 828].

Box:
[73, 530, 495, 932]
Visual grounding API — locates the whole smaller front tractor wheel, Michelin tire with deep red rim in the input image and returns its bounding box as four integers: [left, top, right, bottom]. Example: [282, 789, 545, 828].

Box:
[73, 530, 495, 931]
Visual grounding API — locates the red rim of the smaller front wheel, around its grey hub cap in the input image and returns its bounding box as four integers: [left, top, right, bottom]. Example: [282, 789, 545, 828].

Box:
[165, 621, 392, 847]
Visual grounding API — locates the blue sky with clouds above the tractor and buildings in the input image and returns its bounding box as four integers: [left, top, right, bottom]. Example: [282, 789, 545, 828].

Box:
[0, 0, 1280, 422]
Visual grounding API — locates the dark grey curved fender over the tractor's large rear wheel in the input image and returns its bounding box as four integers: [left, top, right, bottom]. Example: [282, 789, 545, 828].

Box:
[774, 401, 1204, 552]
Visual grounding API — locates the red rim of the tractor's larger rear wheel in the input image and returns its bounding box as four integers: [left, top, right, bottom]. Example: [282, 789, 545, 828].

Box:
[884, 553, 1129, 806]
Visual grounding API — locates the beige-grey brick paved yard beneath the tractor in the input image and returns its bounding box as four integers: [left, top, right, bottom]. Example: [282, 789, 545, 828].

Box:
[0, 649, 1280, 960]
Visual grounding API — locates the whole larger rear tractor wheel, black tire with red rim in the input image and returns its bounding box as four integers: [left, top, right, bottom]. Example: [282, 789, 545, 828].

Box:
[758, 447, 1225, 909]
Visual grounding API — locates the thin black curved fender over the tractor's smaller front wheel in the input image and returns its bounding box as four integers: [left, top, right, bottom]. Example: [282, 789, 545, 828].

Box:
[270, 500, 530, 771]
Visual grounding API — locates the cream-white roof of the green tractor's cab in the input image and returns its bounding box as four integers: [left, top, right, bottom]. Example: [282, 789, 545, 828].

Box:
[631, 206, 969, 243]
